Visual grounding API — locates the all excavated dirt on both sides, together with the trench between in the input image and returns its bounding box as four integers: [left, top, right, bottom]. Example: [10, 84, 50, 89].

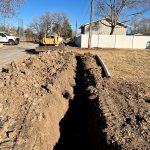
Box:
[0, 51, 150, 150]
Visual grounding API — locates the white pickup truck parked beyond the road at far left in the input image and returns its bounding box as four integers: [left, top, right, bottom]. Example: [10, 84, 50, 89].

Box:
[0, 32, 20, 45]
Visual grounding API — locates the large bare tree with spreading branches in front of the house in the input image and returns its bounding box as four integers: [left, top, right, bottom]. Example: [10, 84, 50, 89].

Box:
[96, 0, 150, 35]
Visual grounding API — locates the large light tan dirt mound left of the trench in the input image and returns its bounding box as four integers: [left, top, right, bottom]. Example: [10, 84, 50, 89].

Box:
[0, 52, 76, 150]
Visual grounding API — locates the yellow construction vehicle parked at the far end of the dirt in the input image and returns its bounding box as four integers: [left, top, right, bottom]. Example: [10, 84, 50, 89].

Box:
[39, 34, 63, 46]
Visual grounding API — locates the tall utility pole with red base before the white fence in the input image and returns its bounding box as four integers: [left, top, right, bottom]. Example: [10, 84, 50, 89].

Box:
[88, 0, 94, 48]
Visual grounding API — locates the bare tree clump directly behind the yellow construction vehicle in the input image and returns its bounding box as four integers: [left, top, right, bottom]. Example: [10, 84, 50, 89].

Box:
[30, 12, 72, 37]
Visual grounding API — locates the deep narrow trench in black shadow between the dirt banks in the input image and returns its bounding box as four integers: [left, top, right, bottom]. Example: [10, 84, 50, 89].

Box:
[54, 56, 117, 150]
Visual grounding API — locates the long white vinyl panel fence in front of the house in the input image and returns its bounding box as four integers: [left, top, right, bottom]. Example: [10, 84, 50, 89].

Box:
[75, 34, 150, 49]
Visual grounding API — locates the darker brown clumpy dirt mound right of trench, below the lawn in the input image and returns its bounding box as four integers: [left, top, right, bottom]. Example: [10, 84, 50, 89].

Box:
[99, 81, 150, 150]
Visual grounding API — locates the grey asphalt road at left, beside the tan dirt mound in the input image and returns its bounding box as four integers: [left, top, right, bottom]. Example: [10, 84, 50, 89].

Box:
[0, 43, 37, 68]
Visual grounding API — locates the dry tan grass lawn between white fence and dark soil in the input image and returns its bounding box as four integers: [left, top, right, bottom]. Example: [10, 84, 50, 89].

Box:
[72, 49, 150, 87]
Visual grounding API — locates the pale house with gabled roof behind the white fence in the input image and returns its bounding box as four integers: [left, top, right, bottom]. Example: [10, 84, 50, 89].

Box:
[80, 18, 127, 35]
